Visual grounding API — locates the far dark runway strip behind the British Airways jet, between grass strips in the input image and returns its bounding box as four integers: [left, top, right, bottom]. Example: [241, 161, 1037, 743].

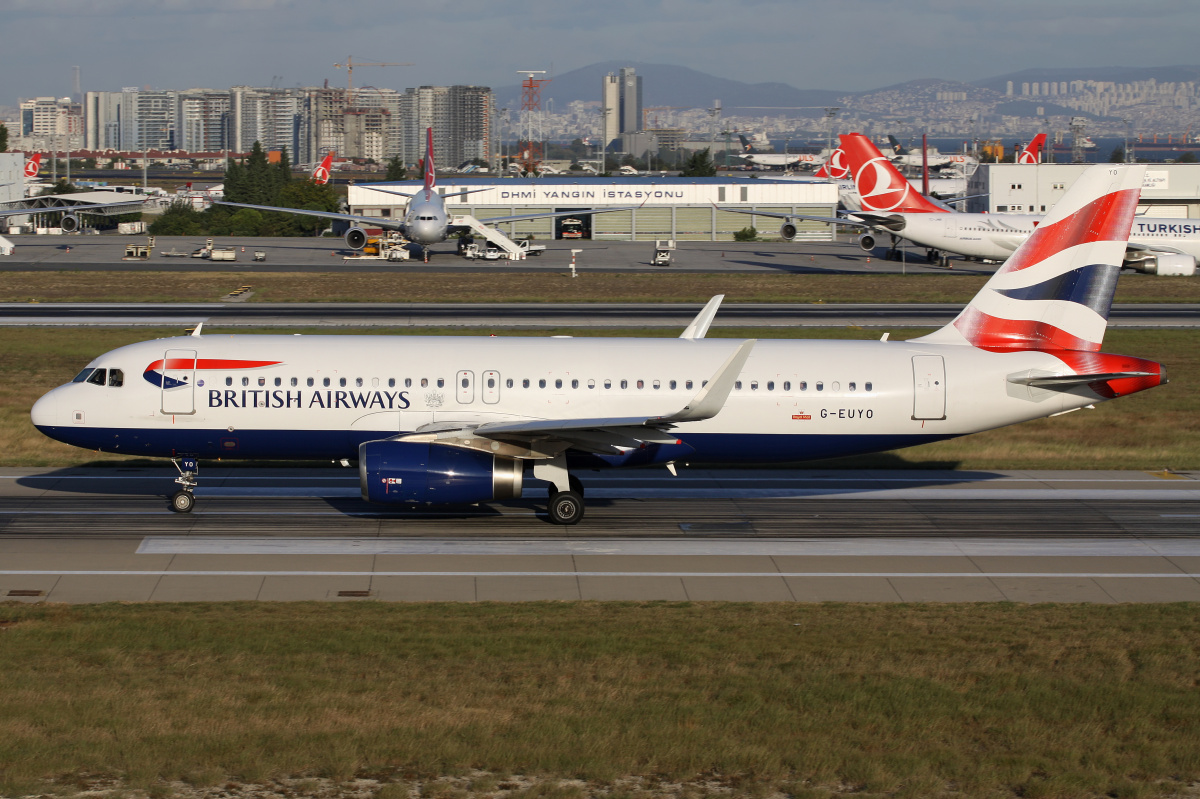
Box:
[0, 302, 1200, 329]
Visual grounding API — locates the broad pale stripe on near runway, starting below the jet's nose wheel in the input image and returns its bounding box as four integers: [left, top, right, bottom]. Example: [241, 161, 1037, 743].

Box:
[137, 535, 1200, 558]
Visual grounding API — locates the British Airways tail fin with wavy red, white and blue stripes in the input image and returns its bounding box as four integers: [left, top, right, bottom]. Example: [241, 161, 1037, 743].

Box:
[919, 164, 1146, 352]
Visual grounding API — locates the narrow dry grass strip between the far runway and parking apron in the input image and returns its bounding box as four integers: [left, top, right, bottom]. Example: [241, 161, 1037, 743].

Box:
[0, 270, 1200, 302]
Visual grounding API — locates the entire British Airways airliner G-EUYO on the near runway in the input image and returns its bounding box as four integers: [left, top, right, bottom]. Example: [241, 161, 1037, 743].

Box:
[30, 164, 1166, 524]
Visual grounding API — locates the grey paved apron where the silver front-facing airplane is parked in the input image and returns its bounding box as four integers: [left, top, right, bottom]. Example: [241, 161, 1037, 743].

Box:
[0, 235, 996, 275]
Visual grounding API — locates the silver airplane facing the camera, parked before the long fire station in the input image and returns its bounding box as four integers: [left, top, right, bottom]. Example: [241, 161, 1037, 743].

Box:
[216, 127, 630, 260]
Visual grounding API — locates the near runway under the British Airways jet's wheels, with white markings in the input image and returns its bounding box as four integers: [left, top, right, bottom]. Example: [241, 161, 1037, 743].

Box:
[0, 468, 1200, 602]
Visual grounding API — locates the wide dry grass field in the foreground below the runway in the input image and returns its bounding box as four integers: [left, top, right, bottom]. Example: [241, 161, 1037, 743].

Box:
[0, 602, 1200, 798]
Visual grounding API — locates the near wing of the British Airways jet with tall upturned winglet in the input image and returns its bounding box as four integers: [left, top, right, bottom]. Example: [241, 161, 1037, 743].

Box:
[397, 338, 757, 455]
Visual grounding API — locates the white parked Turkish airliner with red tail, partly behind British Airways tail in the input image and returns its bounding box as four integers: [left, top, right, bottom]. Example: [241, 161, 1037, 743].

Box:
[841, 133, 1200, 275]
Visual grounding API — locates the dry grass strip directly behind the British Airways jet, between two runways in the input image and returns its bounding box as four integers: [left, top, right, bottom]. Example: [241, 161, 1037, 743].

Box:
[0, 328, 1200, 470]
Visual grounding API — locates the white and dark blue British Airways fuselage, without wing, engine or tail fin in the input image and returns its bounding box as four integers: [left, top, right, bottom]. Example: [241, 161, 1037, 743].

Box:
[32, 336, 1099, 465]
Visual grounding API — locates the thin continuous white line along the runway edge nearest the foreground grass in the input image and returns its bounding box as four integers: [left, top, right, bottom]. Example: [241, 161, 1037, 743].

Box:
[0, 569, 1200, 579]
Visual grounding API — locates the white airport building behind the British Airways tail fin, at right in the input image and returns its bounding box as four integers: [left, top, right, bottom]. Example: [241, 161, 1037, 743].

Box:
[966, 163, 1200, 218]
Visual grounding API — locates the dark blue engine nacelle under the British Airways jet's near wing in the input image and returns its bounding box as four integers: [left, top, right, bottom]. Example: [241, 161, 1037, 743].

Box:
[359, 440, 524, 505]
